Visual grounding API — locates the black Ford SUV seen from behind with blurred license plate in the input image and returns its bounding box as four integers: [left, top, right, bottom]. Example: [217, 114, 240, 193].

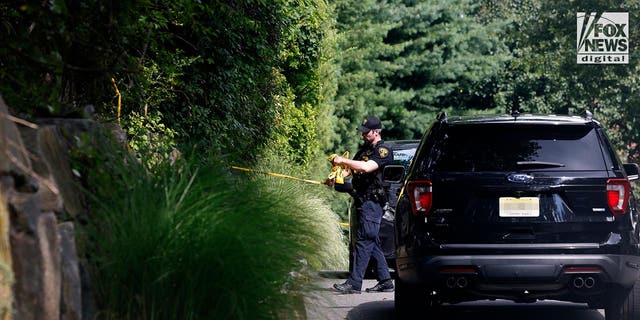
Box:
[395, 113, 640, 320]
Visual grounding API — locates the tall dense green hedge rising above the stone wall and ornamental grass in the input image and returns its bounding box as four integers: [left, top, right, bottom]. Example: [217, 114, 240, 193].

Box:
[0, 0, 332, 166]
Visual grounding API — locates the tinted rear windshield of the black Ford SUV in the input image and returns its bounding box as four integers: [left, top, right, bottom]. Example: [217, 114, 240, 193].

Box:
[430, 124, 606, 172]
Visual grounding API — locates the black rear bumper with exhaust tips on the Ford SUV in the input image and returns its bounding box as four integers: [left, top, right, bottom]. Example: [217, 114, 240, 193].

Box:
[396, 254, 640, 305]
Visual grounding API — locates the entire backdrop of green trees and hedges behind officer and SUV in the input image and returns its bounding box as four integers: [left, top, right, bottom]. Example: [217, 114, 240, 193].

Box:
[0, 0, 640, 318]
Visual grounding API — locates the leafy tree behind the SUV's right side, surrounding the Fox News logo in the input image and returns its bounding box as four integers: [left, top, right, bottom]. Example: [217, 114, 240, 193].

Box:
[485, 0, 640, 161]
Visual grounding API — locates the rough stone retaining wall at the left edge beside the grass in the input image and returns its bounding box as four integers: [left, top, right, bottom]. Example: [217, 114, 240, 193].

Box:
[0, 97, 85, 320]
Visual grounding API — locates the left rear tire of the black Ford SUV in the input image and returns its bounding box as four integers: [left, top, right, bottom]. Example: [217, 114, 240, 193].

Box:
[394, 278, 439, 320]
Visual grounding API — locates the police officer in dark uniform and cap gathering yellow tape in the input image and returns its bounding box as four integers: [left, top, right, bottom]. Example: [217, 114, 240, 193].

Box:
[333, 117, 394, 293]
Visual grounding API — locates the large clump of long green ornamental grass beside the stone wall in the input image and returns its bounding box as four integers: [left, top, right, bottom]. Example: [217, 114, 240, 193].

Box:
[83, 140, 347, 319]
